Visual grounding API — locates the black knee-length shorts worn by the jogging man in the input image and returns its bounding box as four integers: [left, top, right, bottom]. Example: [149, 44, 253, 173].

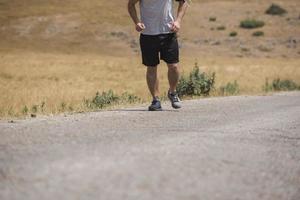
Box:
[140, 33, 179, 67]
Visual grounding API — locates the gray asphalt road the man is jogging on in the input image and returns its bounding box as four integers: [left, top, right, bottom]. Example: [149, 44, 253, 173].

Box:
[0, 92, 300, 200]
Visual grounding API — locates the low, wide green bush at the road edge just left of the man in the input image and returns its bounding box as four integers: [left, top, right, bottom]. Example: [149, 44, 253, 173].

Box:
[84, 90, 141, 109]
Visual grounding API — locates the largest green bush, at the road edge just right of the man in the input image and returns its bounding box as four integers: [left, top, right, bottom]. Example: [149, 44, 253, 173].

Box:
[176, 63, 215, 97]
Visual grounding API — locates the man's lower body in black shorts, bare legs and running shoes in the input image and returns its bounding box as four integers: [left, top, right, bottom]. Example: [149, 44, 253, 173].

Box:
[140, 33, 181, 111]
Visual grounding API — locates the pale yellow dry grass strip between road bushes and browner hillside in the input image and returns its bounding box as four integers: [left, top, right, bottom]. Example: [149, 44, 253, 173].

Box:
[0, 52, 300, 118]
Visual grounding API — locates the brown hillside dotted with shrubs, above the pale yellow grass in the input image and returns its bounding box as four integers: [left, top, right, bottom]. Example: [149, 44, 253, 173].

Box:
[0, 0, 300, 57]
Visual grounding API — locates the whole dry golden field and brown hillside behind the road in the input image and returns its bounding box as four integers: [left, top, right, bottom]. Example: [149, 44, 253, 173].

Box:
[0, 0, 300, 118]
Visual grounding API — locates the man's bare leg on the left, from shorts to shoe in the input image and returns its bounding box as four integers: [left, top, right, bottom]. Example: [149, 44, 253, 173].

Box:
[146, 66, 159, 99]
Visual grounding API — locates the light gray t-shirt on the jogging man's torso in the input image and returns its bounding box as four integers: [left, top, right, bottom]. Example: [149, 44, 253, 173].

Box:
[140, 0, 174, 35]
